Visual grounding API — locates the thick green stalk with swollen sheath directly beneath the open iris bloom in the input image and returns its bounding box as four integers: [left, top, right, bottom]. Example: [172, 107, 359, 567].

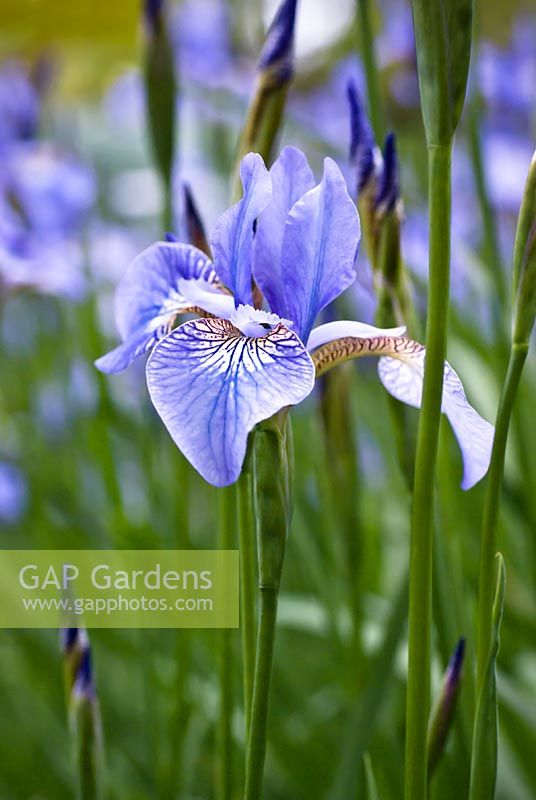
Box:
[244, 412, 292, 800]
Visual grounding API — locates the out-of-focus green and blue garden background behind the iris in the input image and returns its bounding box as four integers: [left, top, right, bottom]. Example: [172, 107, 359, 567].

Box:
[0, 0, 536, 800]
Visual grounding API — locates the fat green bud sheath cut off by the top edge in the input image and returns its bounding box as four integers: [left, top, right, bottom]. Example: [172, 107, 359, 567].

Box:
[412, 0, 473, 145]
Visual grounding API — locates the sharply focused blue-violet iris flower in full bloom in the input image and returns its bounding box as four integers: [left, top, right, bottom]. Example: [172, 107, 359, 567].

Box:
[96, 147, 493, 488]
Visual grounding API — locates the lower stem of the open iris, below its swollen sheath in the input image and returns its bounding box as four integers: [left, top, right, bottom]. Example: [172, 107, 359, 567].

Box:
[244, 586, 279, 800]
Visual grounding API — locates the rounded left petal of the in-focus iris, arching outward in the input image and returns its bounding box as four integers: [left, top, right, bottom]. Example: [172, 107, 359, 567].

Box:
[115, 242, 218, 341]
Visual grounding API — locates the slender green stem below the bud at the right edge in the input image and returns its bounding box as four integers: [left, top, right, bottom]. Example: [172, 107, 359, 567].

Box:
[476, 344, 528, 697]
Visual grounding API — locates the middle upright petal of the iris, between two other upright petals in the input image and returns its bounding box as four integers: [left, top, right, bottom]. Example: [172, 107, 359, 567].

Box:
[253, 147, 315, 314]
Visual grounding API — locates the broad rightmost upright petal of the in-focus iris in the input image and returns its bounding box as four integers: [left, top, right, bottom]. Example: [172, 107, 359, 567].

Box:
[278, 158, 360, 341]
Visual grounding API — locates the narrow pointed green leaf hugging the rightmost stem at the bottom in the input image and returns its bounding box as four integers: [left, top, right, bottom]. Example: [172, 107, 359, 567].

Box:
[469, 553, 505, 800]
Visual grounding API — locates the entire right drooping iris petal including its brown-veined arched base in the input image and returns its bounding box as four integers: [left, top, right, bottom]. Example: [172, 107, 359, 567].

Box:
[312, 336, 494, 489]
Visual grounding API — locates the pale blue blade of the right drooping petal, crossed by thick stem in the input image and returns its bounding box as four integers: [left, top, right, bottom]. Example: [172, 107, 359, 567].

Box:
[378, 340, 494, 489]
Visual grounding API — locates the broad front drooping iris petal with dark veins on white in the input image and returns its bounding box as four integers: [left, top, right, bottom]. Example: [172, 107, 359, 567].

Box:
[147, 319, 314, 486]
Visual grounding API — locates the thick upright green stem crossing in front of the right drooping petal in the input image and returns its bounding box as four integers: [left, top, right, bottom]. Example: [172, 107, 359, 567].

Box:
[405, 142, 452, 800]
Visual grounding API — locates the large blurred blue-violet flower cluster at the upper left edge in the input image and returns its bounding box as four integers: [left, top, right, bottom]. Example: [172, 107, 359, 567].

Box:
[0, 67, 96, 299]
